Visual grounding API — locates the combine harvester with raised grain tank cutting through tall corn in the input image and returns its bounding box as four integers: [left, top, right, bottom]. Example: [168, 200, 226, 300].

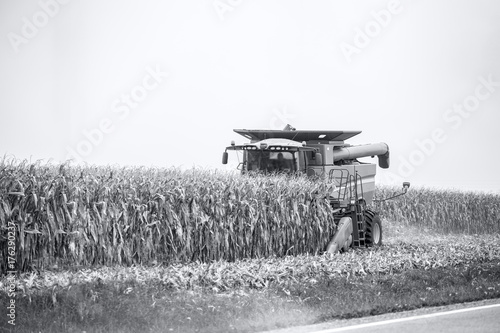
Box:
[222, 125, 410, 253]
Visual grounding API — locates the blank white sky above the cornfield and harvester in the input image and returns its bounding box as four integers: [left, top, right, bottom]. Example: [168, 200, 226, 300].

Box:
[0, 0, 500, 192]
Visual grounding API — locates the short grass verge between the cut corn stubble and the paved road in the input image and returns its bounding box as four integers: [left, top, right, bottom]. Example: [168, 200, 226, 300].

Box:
[0, 260, 500, 332]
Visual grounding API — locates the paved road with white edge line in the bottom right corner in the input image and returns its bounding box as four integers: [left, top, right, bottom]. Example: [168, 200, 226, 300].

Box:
[264, 300, 500, 333]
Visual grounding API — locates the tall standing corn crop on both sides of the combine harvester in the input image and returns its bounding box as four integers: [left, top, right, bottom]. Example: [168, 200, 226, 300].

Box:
[0, 158, 500, 272]
